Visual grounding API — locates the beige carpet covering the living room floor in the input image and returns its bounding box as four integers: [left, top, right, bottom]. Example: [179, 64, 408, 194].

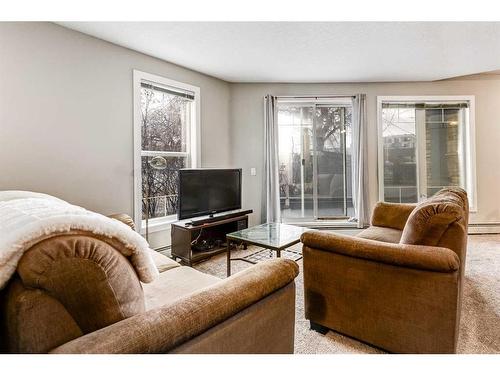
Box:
[195, 235, 500, 354]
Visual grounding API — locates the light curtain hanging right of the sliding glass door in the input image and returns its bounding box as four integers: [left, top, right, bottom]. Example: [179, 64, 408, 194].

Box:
[351, 94, 370, 228]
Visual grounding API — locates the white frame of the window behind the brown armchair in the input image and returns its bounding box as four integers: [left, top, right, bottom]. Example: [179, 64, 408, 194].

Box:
[377, 95, 477, 212]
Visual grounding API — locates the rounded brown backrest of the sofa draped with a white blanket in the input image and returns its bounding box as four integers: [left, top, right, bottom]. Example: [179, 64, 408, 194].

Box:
[0, 234, 145, 353]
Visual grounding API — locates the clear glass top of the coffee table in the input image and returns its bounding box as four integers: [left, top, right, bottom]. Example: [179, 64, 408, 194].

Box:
[226, 223, 309, 250]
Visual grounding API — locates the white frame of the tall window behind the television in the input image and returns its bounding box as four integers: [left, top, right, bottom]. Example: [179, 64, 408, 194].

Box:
[133, 69, 201, 233]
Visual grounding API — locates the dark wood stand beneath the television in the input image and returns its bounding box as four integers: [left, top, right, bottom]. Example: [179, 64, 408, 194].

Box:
[171, 211, 248, 266]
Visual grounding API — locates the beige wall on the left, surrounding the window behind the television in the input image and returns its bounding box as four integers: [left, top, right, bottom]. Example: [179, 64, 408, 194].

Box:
[0, 23, 230, 248]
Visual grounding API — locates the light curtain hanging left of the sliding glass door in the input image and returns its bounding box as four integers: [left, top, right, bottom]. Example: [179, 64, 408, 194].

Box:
[262, 95, 281, 223]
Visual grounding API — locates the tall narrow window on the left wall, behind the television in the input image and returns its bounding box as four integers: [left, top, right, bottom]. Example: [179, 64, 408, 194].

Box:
[134, 71, 200, 231]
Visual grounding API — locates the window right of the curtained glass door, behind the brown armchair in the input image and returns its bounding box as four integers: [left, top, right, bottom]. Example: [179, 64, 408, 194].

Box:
[378, 97, 476, 209]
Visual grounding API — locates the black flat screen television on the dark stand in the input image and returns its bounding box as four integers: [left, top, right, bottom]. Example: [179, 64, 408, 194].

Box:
[177, 168, 241, 220]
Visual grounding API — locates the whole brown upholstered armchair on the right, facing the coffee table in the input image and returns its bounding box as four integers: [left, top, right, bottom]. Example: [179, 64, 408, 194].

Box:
[302, 189, 468, 353]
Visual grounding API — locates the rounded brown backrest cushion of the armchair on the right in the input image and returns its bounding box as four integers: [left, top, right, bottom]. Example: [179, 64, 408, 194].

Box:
[400, 188, 469, 263]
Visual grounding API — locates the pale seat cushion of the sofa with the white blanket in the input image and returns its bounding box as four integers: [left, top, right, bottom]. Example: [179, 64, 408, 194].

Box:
[143, 267, 221, 310]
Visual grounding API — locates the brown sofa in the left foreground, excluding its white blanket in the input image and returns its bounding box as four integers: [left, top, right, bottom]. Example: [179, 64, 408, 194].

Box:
[0, 215, 298, 353]
